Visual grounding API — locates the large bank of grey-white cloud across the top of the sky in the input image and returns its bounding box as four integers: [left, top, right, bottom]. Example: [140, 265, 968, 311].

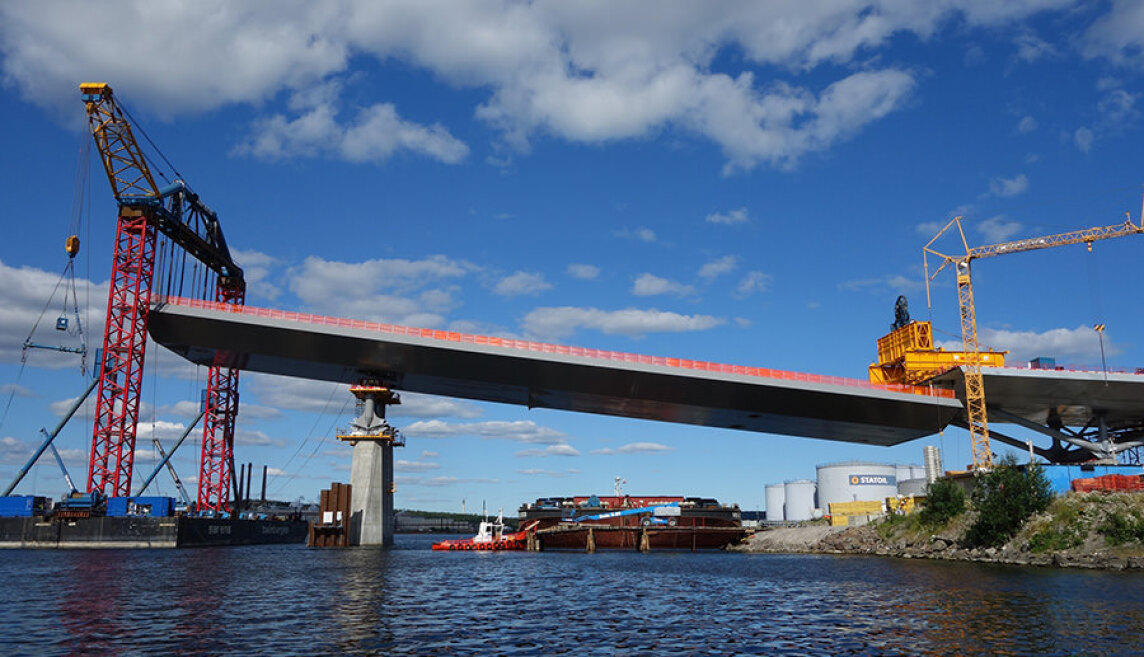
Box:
[0, 0, 1107, 172]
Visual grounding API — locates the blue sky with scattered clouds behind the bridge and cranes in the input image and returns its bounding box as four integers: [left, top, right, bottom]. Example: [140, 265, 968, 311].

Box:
[0, 0, 1144, 513]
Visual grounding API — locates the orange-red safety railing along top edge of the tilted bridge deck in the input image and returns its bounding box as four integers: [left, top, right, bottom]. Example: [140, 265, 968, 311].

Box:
[159, 296, 954, 398]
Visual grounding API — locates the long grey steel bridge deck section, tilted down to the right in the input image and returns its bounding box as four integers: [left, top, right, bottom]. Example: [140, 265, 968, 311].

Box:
[149, 298, 962, 445]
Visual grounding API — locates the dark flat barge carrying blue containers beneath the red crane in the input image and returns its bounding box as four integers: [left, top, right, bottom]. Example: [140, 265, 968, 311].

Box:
[0, 496, 309, 548]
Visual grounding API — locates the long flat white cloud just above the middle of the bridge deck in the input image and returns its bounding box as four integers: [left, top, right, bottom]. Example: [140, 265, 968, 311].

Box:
[522, 306, 724, 340]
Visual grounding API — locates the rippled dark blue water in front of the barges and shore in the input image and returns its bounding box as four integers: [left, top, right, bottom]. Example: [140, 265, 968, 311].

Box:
[0, 536, 1144, 657]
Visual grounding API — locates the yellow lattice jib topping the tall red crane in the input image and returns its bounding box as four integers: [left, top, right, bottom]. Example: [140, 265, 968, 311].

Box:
[79, 82, 159, 201]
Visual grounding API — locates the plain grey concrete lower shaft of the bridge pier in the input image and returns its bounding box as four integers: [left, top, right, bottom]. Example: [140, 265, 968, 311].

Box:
[350, 440, 394, 545]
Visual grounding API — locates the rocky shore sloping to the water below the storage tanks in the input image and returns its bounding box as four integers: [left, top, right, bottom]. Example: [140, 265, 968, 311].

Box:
[729, 498, 1144, 570]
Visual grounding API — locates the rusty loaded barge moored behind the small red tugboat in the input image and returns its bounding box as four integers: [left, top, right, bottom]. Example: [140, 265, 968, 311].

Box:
[518, 496, 750, 552]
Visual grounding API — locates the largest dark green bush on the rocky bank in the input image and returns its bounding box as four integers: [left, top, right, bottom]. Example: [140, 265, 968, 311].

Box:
[966, 456, 1052, 547]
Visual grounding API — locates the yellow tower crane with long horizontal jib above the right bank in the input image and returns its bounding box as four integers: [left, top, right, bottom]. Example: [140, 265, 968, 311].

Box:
[922, 203, 1144, 469]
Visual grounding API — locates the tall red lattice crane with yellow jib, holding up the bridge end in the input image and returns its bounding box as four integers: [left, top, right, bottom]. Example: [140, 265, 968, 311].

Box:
[80, 82, 246, 512]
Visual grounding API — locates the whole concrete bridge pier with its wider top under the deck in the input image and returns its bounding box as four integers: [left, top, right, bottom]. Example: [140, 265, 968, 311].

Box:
[337, 381, 405, 545]
